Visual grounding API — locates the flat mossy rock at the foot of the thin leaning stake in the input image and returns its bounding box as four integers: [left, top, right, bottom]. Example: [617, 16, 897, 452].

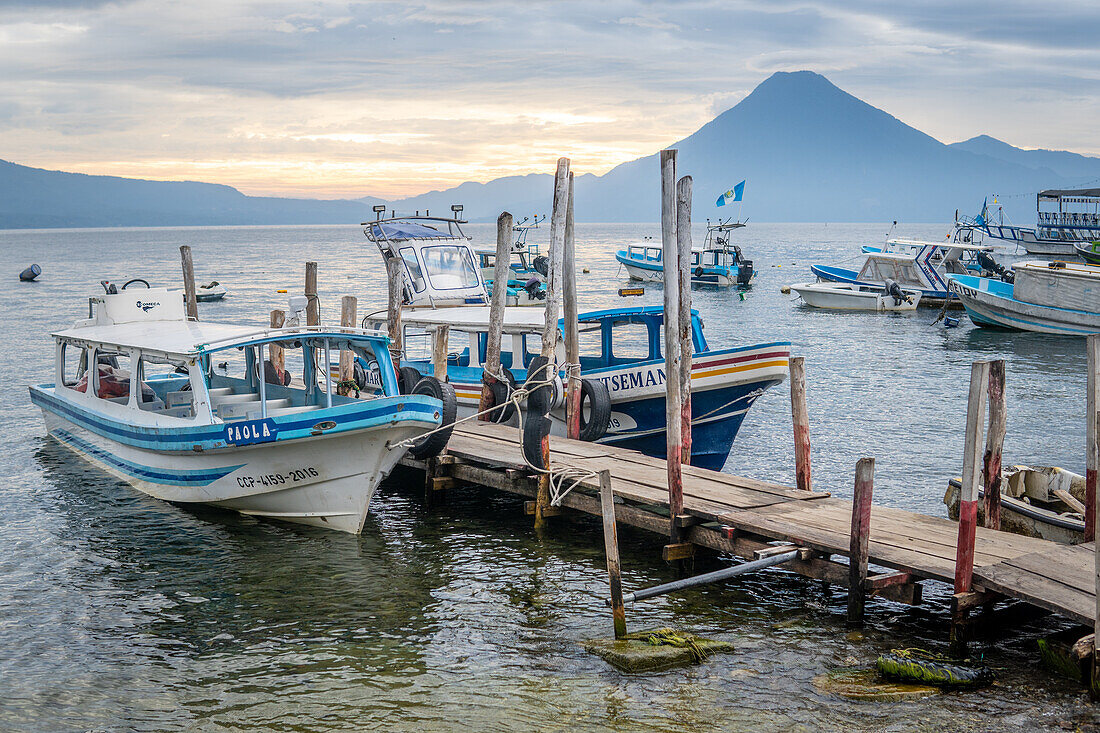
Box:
[583, 628, 734, 672]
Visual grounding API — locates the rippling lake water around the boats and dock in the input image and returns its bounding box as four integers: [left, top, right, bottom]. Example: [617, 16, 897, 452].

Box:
[0, 223, 1100, 731]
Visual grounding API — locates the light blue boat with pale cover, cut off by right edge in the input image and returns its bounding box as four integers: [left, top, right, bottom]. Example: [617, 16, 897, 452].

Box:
[950, 262, 1100, 336]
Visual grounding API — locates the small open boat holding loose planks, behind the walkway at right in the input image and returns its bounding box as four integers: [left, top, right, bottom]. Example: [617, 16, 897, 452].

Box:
[944, 466, 1085, 545]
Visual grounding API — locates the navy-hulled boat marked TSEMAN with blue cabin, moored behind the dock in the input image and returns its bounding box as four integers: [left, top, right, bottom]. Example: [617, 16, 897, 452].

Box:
[391, 306, 791, 470]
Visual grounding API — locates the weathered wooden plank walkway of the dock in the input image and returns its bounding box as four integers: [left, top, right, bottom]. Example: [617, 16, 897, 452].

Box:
[424, 423, 1096, 624]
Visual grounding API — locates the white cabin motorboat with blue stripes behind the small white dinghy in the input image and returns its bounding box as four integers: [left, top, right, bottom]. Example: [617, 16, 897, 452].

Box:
[810, 240, 996, 305]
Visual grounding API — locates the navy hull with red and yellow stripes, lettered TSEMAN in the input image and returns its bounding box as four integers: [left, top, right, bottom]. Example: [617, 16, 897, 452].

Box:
[442, 341, 791, 470]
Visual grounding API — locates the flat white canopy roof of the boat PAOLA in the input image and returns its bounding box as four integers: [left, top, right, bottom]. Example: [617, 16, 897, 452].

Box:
[53, 320, 388, 360]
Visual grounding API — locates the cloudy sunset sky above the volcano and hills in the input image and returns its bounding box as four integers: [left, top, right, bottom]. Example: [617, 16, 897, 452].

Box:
[0, 0, 1100, 198]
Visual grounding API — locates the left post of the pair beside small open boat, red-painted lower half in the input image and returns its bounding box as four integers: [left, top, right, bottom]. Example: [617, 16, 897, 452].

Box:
[952, 361, 989, 654]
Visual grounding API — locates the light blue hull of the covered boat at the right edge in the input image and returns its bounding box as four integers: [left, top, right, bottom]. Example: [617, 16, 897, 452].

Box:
[950, 275, 1100, 336]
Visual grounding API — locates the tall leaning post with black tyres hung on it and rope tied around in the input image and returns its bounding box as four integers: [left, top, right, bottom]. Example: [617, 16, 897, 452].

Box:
[528, 157, 569, 529]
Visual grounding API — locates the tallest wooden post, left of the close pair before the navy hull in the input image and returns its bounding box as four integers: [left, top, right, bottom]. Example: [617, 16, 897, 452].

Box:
[661, 150, 684, 559]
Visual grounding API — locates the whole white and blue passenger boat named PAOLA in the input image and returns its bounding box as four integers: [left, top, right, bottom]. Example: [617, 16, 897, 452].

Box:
[30, 288, 446, 533]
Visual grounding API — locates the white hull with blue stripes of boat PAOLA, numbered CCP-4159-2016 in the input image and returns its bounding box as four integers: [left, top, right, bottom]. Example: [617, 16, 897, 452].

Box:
[32, 392, 439, 534]
